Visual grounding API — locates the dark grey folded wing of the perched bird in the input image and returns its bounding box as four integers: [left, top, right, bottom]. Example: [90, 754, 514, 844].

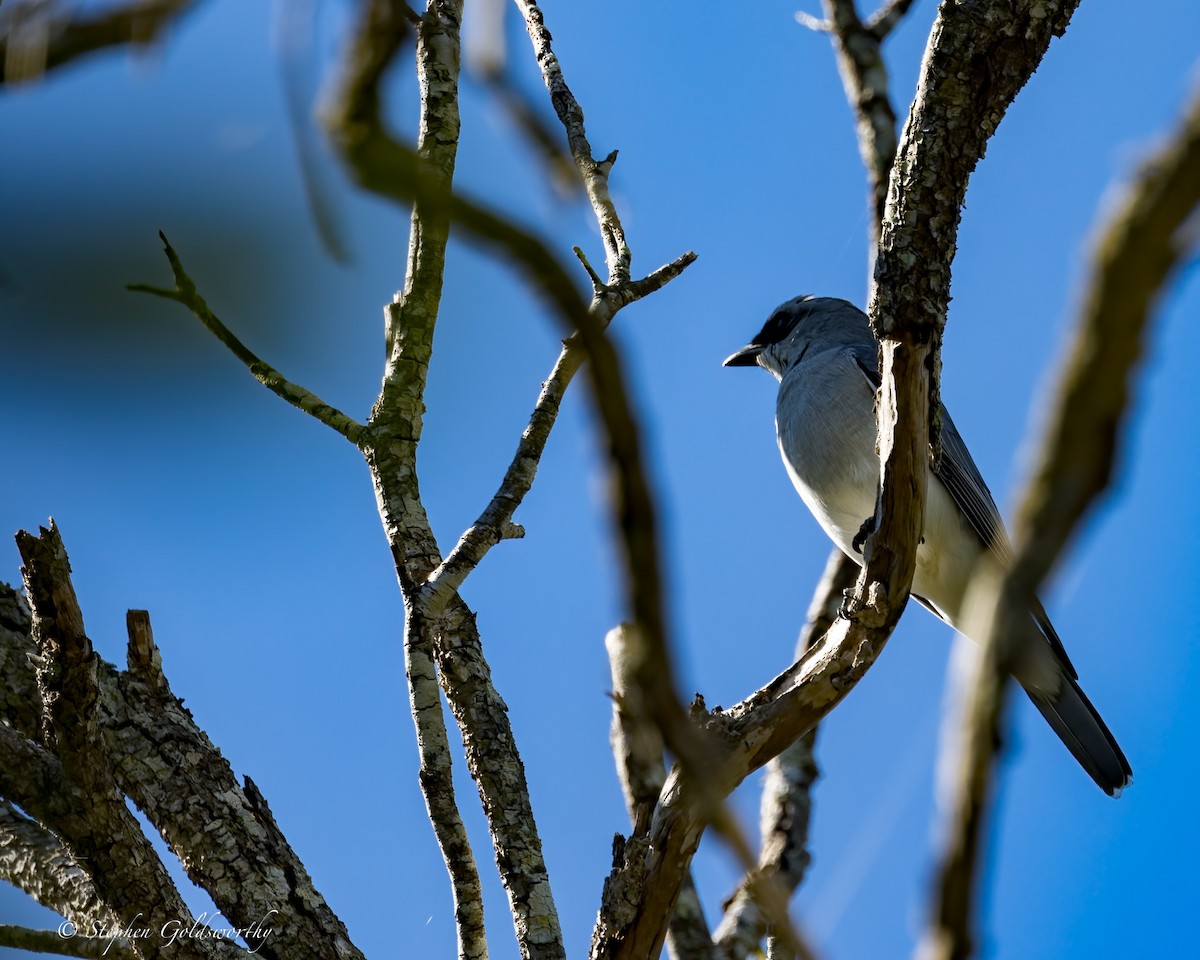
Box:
[853, 347, 1079, 679]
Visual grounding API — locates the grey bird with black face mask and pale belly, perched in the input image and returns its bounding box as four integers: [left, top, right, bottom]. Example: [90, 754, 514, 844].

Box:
[725, 296, 1133, 796]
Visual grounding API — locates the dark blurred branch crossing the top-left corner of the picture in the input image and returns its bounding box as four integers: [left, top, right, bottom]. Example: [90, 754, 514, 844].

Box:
[0, 0, 197, 84]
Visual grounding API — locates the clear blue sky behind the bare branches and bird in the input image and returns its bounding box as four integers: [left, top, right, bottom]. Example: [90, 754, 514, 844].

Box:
[0, 0, 1200, 960]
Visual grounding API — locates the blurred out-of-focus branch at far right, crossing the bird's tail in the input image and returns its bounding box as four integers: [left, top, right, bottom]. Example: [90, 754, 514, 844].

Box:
[919, 76, 1200, 960]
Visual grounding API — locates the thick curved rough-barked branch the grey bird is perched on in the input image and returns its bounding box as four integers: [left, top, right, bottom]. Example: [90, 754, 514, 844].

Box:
[599, 0, 1089, 958]
